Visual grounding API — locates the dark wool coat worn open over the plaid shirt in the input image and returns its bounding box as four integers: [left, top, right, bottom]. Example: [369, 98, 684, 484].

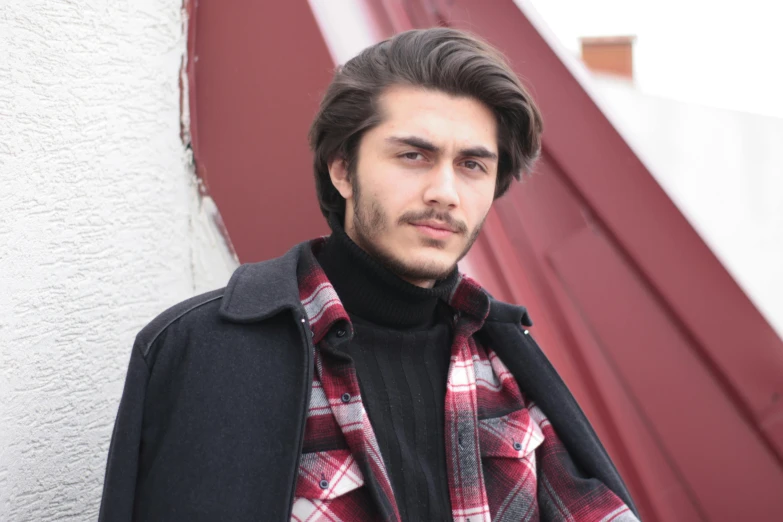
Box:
[99, 243, 638, 522]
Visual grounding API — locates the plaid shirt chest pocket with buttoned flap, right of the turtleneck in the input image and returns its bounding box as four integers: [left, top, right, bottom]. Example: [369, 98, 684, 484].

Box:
[479, 408, 544, 521]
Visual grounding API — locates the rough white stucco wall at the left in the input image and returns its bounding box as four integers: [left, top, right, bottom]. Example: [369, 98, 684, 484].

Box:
[0, 0, 236, 522]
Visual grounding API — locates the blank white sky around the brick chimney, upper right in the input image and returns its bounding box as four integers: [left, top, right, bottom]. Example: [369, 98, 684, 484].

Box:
[516, 0, 783, 118]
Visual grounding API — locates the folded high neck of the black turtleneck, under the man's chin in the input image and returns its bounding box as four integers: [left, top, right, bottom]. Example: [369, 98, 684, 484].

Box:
[317, 211, 459, 328]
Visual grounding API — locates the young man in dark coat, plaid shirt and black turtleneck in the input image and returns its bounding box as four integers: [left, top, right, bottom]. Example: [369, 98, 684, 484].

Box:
[101, 28, 637, 522]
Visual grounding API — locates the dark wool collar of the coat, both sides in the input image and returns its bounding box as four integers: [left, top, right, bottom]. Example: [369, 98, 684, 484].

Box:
[220, 241, 533, 326]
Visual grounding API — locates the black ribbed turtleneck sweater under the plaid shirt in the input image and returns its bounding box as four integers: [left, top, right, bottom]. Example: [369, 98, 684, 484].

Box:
[317, 220, 457, 522]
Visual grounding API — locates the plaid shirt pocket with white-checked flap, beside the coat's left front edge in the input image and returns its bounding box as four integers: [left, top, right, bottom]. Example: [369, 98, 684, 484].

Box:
[291, 449, 370, 522]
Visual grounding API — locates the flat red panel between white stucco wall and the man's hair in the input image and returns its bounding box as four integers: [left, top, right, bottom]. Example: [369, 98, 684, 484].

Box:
[190, 0, 334, 262]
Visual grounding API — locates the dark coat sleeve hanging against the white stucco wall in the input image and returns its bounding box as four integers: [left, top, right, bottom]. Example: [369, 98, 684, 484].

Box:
[98, 338, 150, 522]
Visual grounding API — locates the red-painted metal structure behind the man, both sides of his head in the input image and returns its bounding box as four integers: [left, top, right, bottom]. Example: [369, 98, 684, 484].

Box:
[189, 0, 783, 522]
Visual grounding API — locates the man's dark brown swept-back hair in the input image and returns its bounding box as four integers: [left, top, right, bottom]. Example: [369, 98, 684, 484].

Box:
[309, 27, 542, 218]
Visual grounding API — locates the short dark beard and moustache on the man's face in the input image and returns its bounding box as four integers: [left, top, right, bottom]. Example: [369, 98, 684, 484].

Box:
[351, 173, 486, 282]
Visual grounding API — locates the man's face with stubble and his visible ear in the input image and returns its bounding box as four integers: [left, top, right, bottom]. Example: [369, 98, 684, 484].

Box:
[330, 86, 498, 287]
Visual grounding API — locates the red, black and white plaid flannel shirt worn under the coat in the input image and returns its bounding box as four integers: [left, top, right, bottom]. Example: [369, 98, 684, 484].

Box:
[292, 239, 637, 522]
